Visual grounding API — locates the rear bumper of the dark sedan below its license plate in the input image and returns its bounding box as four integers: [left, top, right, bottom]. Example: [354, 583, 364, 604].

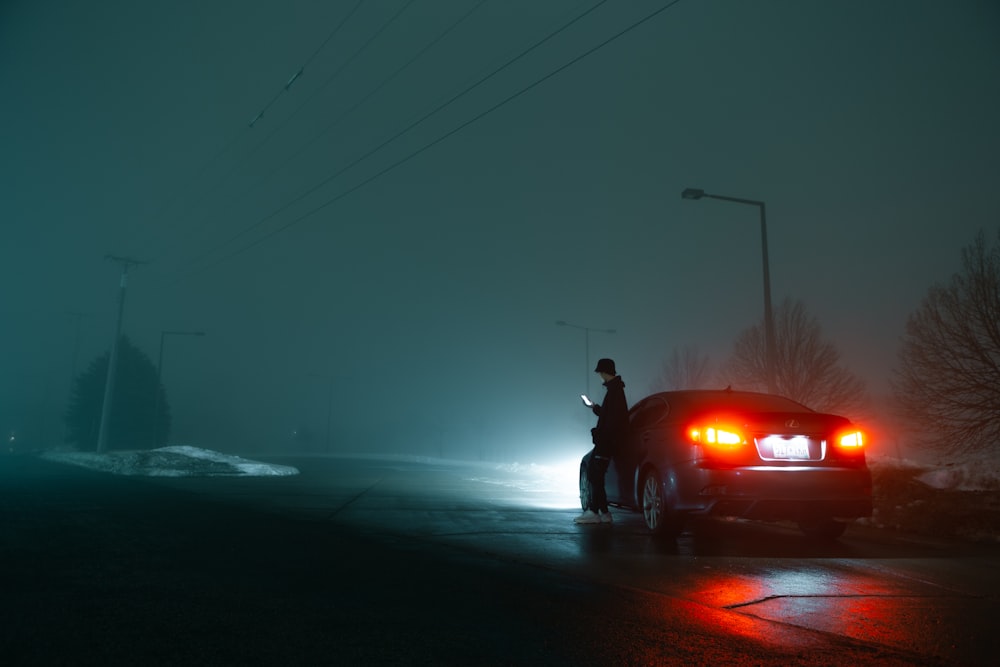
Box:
[678, 467, 872, 521]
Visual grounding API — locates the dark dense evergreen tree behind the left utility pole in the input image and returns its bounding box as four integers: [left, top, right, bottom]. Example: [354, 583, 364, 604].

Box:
[65, 336, 171, 451]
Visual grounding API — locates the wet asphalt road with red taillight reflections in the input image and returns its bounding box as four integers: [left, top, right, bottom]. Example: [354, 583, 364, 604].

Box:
[0, 456, 1000, 665]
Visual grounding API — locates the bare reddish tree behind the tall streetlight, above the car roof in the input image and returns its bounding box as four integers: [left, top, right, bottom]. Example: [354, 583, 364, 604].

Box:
[719, 299, 868, 417]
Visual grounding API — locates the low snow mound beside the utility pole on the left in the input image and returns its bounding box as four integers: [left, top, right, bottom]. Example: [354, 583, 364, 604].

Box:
[42, 445, 299, 477]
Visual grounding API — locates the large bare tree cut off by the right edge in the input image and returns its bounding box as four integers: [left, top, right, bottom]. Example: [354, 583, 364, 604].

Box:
[891, 230, 1000, 454]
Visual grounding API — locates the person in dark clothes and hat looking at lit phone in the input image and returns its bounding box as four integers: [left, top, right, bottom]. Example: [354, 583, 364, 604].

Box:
[575, 359, 628, 523]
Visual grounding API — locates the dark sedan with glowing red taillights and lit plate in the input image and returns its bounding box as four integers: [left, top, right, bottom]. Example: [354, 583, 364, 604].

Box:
[580, 389, 872, 539]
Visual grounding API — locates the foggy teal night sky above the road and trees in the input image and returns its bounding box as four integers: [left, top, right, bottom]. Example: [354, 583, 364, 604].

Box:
[0, 0, 1000, 458]
